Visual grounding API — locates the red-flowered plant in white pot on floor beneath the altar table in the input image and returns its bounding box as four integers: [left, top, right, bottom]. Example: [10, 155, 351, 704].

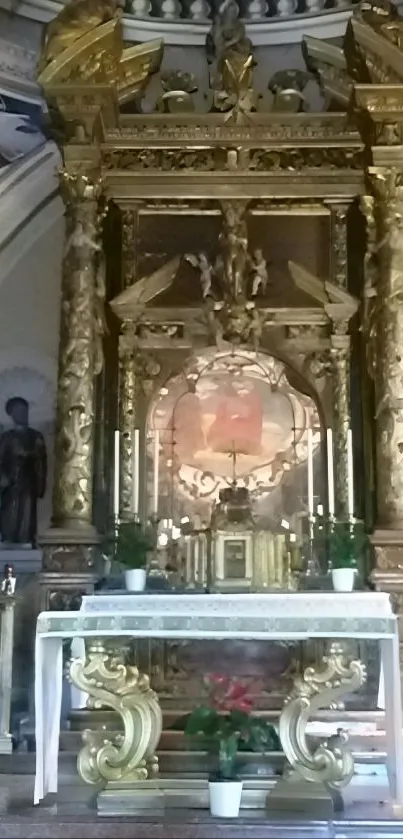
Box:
[175, 675, 281, 818]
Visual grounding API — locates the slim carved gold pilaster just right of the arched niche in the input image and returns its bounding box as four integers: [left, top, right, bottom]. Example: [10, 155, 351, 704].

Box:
[330, 321, 351, 518]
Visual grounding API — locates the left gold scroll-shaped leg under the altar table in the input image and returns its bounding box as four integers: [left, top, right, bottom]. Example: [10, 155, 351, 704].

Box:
[70, 639, 162, 795]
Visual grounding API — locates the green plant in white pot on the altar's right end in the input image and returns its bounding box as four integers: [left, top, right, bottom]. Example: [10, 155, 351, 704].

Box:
[328, 521, 366, 591]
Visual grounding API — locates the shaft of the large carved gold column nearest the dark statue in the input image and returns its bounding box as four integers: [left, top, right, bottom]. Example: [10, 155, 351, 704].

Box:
[52, 171, 104, 531]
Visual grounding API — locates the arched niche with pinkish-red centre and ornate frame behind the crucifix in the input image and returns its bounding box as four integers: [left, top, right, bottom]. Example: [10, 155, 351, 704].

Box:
[147, 348, 326, 530]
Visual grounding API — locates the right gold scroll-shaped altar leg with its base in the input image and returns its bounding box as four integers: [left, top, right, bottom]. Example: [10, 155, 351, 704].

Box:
[268, 642, 366, 818]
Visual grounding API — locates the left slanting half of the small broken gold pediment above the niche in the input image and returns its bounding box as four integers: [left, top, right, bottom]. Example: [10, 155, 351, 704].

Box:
[109, 256, 181, 321]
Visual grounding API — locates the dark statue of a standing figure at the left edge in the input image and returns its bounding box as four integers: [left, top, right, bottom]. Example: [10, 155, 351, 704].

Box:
[0, 396, 47, 547]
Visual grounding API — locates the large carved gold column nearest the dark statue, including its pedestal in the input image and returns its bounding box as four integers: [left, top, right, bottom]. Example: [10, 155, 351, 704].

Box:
[39, 170, 104, 608]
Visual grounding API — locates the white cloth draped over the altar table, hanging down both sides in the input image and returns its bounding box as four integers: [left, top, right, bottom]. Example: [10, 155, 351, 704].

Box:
[34, 592, 403, 805]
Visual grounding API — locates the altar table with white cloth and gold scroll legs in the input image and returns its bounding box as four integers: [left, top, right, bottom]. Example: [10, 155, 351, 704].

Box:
[34, 592, 403, 805]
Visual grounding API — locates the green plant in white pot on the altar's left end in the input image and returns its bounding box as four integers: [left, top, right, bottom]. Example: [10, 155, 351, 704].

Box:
[114, 521, 153, 591]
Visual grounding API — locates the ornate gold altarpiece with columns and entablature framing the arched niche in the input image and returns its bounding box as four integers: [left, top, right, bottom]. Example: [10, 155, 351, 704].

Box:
[34, 0, 403, 708]
